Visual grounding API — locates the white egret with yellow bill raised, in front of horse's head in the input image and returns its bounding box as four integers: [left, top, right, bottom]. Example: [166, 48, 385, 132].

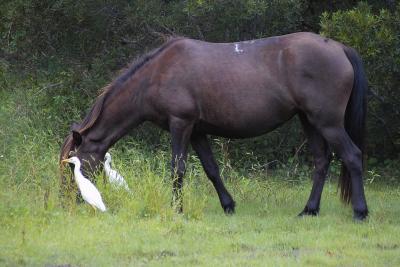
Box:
[61, 157, 106, 212]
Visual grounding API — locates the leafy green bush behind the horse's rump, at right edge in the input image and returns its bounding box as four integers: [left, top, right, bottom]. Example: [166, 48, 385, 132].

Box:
[321, 3, 400, 158]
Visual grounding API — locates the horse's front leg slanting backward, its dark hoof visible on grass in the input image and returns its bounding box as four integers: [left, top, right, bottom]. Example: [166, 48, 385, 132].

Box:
[191, 134, 235, 214]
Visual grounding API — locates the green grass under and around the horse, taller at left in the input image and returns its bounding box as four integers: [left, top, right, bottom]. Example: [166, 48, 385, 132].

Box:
[0, 76, 400, 266]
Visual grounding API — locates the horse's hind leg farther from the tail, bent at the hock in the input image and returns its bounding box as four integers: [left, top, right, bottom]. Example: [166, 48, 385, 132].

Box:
[299, 115, 331, 216]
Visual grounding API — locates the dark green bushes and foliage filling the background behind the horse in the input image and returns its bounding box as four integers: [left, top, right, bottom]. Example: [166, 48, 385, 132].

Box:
[0, 0, 400, 178]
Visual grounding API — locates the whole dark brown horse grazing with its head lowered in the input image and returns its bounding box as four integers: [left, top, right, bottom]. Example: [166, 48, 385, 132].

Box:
[60, 33, 368, 219]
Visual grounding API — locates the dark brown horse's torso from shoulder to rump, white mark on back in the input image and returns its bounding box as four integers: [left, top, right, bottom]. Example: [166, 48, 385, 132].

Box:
[149, 33, 352, 137]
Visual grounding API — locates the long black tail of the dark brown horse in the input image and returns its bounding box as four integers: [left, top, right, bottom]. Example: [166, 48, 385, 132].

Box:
[339, 46, 368, 203]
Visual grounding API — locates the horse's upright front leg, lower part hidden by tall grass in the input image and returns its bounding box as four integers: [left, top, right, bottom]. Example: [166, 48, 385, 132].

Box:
[169, 117, 193, 212]
